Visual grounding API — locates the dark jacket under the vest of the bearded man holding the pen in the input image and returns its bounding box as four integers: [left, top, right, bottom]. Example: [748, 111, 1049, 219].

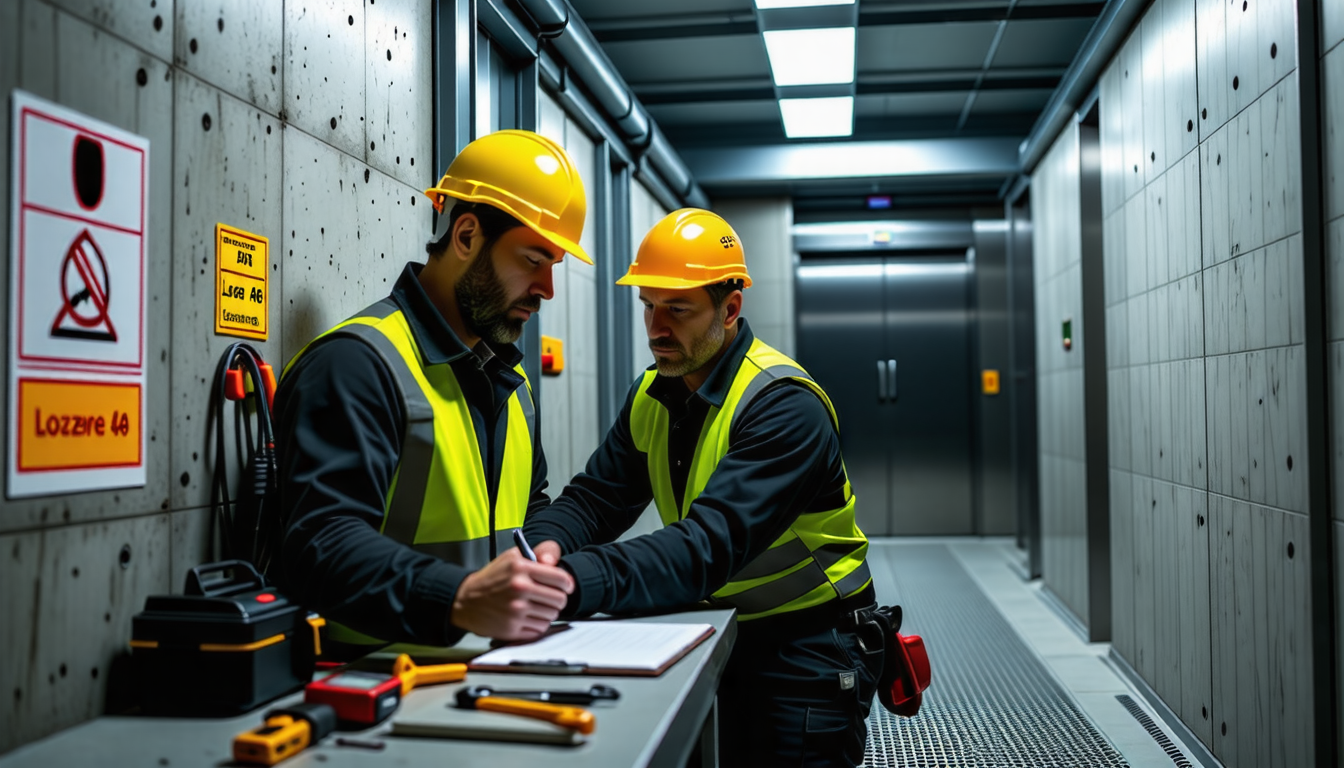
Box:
[273, 264, 548, 646]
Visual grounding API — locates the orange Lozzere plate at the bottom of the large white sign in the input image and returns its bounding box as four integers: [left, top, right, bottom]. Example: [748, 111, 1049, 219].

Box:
[17, 378, 141, 472]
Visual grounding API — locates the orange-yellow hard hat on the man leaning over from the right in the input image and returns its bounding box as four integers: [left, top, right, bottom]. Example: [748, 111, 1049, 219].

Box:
[616, 208, 751, 288]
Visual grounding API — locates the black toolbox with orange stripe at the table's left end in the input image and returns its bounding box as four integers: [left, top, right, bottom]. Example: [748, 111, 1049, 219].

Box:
[130, 561, 316, 717]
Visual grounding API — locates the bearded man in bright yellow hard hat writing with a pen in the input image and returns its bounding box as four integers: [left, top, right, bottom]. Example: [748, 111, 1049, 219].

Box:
[273, 130, 591, 656]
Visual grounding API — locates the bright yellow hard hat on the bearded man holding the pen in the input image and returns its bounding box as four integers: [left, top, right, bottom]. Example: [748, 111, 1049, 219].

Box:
[425, 130, 593, 264]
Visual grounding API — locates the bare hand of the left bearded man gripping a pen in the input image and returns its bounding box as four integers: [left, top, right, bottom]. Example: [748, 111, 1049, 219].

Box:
[450, 542, 574, 640]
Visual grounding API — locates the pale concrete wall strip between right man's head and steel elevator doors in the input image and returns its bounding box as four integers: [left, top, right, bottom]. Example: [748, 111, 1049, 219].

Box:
[714, 198, 798, 355]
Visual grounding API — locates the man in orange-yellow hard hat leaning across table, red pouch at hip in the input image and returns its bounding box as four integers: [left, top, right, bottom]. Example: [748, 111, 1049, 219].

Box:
[524, 208, 883, 767]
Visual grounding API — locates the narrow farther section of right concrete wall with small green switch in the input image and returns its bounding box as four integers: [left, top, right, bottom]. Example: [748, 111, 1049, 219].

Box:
[1032, 124, 1087, 616]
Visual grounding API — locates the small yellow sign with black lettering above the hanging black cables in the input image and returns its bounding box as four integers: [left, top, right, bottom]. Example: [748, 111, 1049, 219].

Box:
[215, 223, 270, 342]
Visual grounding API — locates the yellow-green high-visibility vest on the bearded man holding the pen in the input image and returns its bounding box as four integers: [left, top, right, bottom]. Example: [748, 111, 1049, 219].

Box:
[285, 299, 536, 644]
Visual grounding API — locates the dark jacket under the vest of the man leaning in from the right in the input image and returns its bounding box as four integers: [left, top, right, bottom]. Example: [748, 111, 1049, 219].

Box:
[523, 320, 845, 616]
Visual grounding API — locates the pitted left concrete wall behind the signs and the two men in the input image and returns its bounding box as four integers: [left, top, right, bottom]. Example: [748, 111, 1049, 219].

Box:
[0, 0, 664, 753]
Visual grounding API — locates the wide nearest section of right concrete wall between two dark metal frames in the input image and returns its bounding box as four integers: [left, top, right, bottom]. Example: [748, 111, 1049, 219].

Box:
[1091, 0, 1311, 767]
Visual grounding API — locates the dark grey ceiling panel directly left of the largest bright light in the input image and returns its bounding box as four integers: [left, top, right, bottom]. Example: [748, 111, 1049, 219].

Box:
[602, 35, 770, 86]
